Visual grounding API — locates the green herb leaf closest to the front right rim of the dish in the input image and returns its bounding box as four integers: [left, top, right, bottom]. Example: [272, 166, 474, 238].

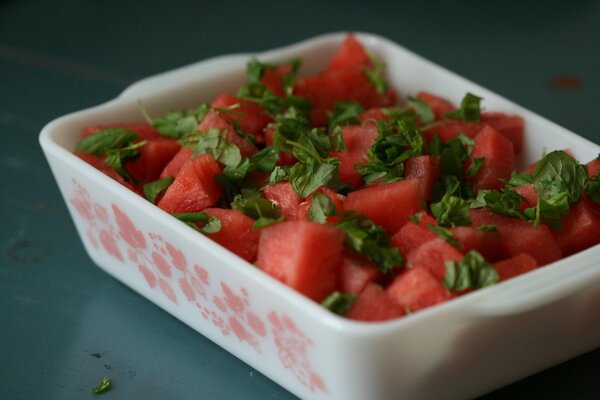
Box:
[442, 250, 500, 292]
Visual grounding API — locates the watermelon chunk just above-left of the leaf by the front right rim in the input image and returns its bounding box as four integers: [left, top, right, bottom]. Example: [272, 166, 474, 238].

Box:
[406, 238, 463, 281]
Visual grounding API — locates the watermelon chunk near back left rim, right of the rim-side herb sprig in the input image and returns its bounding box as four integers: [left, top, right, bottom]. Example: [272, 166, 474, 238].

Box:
[212, 93, 272, 140]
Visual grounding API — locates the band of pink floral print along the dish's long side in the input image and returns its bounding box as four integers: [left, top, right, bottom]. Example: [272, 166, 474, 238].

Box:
[69, 180, 327, 392]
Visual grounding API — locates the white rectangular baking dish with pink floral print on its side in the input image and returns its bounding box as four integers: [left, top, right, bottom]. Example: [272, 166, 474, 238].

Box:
[40, 33, 600, 400]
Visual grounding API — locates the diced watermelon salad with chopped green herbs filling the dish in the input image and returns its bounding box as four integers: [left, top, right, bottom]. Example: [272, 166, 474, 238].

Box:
[75, 34, 600, 321]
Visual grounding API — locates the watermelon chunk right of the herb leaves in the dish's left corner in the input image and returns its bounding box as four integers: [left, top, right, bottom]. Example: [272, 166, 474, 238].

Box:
[127, 138, 181, 183]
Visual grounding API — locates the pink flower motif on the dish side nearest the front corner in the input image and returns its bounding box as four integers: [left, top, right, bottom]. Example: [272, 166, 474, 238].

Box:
[268, 311, 327, 391]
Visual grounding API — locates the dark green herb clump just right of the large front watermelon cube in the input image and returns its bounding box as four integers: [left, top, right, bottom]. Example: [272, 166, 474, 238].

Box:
[335, 212, 404, 273]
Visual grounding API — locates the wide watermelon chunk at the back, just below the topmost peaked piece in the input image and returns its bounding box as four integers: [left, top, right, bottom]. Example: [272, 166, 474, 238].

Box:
[294, 67, 396, 126]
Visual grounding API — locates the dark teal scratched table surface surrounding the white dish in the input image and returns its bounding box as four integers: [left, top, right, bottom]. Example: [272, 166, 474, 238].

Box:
[0, 0, 600, 399]
